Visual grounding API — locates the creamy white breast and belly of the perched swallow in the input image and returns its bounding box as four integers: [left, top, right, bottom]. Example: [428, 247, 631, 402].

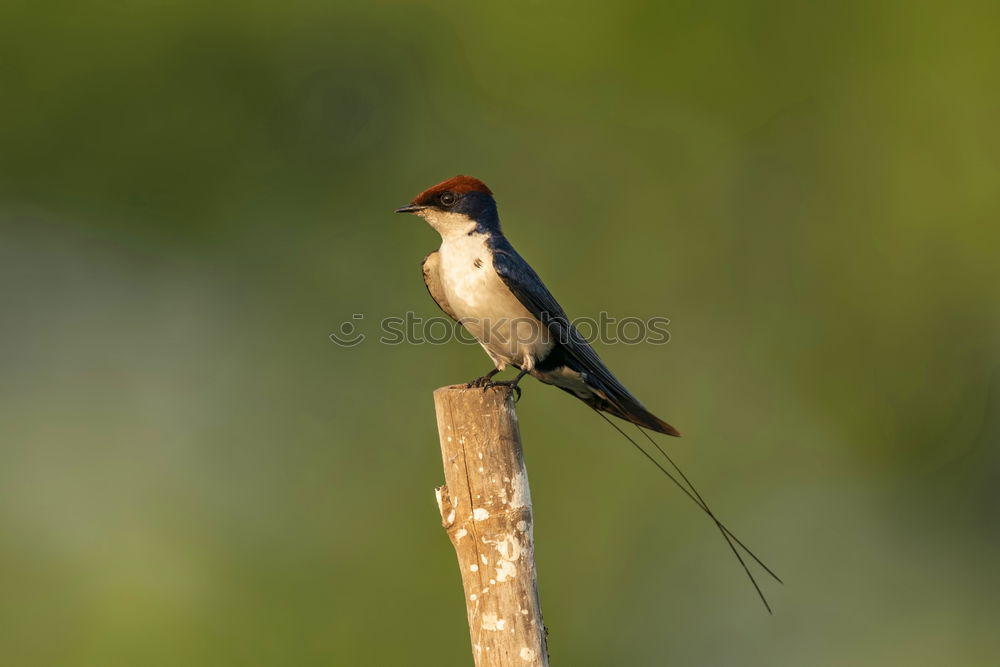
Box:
[440, 233, 553, 370]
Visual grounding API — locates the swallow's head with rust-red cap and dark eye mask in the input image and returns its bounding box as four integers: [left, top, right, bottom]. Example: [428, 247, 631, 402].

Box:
[396, 176, 500, 238]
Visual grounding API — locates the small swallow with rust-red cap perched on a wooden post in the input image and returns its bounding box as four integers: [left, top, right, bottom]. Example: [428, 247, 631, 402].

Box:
[396, 176, 680, 436]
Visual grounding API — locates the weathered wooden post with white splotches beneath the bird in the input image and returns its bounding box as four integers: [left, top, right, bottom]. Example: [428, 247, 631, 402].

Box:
[434, 385, 549, 667]
